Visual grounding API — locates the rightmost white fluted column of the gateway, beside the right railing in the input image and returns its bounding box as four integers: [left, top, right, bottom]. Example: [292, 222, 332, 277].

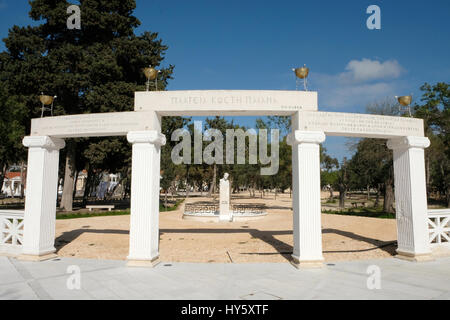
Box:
[387, 137, 431, 261]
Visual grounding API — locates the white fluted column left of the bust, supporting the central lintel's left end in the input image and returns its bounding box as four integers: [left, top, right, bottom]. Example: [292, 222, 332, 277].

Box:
[127, 130, 166, 267]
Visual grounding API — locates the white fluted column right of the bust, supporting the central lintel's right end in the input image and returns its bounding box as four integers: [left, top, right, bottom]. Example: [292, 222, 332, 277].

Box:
[289, 130, 325, 267]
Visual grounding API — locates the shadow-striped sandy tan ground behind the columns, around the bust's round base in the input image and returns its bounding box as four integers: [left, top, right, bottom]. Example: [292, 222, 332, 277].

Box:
[56, 194, 396, 263]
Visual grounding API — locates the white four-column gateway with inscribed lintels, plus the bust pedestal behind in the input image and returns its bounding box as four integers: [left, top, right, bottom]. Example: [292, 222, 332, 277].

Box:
[7, 90, 430, 267]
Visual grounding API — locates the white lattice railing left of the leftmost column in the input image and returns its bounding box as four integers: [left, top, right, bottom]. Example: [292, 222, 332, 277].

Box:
[0, 210, 24, 255]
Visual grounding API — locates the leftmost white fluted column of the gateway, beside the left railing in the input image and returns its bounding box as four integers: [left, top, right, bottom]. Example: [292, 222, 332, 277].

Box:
[19, 136, 65, 261]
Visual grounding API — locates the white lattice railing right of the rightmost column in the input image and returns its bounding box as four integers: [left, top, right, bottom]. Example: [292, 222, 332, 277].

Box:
[428, 209, 450, 246]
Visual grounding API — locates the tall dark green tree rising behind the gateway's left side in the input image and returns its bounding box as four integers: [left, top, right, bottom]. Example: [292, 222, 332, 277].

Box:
[1, 0, 174, 207]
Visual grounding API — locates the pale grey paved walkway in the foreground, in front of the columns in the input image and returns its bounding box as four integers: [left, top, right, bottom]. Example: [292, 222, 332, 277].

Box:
[0, 257, 450, 300]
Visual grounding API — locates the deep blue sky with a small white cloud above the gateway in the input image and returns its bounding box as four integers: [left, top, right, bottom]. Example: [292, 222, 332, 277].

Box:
[0, 0, 450, 159]
